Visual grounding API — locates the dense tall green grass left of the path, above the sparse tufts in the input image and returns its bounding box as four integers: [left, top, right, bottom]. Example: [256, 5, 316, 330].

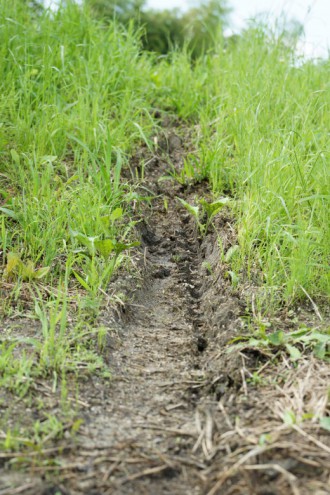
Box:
[0, 0, 152, 288]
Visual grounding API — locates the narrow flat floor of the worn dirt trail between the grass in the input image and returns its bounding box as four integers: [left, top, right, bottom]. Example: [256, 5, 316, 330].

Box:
[69, 133, 217, 495]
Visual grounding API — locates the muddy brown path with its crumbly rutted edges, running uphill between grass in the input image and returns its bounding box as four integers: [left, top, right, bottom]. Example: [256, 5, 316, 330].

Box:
[28, 130, 242, 495]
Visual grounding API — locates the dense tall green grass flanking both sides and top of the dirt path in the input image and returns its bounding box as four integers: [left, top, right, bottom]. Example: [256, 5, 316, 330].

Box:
[0, 2, 329, 326]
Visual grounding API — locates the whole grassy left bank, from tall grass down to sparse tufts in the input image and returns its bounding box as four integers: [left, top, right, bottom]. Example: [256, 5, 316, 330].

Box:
[0, 1, 157, 414]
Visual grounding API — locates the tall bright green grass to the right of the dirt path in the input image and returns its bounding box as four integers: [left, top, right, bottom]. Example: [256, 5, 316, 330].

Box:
[158, 28, 330, 306]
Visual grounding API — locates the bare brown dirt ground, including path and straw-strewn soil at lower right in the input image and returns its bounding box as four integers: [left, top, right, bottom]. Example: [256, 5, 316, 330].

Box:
[0, 124, 330, 495]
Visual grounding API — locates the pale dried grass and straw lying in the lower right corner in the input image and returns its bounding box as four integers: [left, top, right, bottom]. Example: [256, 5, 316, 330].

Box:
[204, 357, 330, 495]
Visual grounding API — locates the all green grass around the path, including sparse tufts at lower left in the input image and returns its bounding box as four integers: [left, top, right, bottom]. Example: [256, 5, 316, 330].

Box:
[0, 0, 330, 472]
